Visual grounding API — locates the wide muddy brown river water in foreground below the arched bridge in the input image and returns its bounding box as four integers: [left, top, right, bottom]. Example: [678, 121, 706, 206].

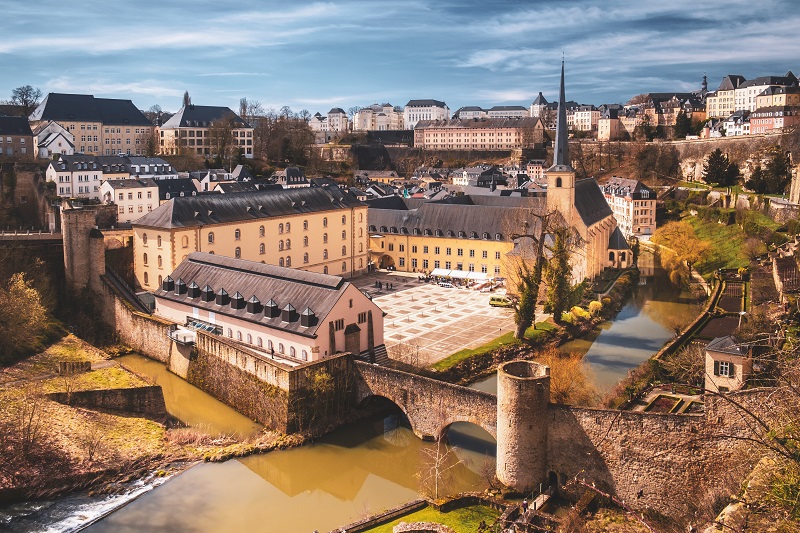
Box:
[86, 417, 494, 533]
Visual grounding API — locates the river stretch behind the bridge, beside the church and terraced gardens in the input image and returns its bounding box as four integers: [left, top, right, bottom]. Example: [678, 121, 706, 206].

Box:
[472, 256, 700, 393]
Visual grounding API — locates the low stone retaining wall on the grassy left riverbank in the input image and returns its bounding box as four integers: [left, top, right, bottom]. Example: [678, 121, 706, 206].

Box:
[48, 385, 167, 417]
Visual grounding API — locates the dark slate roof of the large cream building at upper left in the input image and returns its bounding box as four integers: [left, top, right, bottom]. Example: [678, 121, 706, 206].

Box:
[30, 93, 153, 126]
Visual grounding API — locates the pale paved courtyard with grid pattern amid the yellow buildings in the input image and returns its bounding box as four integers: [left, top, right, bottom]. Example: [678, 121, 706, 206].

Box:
[351, 271, 514, 366]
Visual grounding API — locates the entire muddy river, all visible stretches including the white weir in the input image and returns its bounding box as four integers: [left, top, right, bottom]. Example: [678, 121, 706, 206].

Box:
[0, 256, 699, 533]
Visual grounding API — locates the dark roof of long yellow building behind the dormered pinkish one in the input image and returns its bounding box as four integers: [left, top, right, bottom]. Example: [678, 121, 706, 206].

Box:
[136, 185, 365, 228]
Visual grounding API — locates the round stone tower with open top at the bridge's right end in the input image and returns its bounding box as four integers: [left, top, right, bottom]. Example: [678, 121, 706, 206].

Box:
[497, 361, 550, 491]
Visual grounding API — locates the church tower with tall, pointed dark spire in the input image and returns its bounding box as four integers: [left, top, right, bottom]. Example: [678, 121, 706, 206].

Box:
[547, 61, 575, 223]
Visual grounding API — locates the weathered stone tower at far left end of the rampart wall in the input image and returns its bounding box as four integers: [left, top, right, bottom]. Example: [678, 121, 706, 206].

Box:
[61, 204, 106, 291]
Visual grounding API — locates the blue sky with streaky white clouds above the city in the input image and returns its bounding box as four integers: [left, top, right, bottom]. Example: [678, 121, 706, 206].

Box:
[0, 0, 800, 114]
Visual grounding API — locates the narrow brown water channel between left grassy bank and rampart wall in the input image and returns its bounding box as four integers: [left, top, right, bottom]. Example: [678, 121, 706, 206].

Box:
[117, 354, 264, 437]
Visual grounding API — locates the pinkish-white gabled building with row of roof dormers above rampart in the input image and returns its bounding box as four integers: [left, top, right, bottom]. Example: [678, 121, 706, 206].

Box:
[154, 252, 384, 364]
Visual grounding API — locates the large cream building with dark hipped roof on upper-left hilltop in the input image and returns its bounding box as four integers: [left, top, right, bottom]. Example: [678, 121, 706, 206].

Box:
[29, 93, 154, 155]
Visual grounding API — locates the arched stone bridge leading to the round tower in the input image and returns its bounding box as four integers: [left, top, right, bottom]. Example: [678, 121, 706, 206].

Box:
[356, 361, 497, 440]
